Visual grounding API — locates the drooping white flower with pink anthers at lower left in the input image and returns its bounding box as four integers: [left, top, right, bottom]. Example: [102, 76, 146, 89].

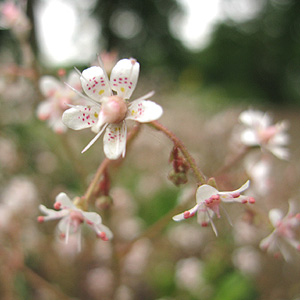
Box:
[38, 193, 113, 251]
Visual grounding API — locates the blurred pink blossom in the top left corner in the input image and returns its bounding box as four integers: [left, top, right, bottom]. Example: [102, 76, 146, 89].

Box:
[0, 0, 31, 38]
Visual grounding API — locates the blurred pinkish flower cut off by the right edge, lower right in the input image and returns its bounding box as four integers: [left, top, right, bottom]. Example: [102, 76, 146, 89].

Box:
[260, 201, 300, 261]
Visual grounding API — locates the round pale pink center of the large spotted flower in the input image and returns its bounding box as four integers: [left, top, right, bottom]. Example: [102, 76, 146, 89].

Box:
[101, 96, 127, 124]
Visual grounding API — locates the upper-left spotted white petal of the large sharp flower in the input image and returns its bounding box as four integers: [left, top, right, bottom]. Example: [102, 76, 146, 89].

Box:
[80, 67, 111, 102]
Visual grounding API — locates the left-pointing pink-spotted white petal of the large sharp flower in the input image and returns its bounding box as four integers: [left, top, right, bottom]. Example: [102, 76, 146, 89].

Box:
[62, 105, 100, 130]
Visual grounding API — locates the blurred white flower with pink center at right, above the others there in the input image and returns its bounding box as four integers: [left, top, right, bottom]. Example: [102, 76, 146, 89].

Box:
[239, 109, 289, 159]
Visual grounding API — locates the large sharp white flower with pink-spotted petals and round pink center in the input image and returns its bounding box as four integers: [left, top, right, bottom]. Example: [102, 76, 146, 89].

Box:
[63, 59, 163, 159]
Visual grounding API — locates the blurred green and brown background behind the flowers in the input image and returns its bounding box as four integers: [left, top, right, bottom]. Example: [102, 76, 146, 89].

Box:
[0, 0, 300, 300]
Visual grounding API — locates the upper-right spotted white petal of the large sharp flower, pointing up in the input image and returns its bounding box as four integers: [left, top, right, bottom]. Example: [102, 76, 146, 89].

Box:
[110, 58, 140, 99]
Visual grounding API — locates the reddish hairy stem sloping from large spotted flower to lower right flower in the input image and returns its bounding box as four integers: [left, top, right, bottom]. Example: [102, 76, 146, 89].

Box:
[149, 121, 206, 184]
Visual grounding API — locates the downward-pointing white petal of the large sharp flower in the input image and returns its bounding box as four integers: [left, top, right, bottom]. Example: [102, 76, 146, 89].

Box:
[103, 122, 127, 159]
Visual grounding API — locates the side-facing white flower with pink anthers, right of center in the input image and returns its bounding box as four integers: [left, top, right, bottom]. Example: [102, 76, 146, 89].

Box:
[173, 180, 255, 235]
